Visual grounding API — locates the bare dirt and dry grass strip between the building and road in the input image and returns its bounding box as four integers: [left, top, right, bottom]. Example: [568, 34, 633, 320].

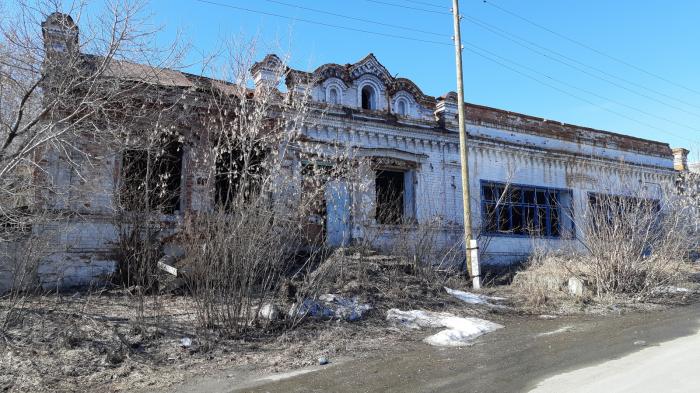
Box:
[0, 259, 697, 392]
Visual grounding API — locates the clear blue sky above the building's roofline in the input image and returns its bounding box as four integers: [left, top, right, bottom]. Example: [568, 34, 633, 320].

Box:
[71, 0, 700, 161]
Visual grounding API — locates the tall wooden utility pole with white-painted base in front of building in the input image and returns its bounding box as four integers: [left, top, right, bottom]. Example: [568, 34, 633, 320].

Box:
[452, 0, 481, 289]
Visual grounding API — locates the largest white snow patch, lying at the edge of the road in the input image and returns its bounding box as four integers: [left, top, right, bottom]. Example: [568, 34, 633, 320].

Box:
[386, 308, 503, 347]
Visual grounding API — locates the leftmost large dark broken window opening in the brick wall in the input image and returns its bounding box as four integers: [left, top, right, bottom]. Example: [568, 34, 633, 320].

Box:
[120, 139, 182, 214]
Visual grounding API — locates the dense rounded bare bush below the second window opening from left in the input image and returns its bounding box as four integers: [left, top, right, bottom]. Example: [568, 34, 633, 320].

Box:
[182, 204, 300, 334]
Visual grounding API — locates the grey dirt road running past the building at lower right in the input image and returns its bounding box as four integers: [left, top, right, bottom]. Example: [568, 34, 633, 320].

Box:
[170, 304, 700, 392]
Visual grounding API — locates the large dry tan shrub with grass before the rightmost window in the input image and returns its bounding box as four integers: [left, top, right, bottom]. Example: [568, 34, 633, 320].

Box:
[513, 182, 698, 300]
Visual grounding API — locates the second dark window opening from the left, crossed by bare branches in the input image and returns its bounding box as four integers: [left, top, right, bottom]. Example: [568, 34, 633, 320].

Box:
[214, 148, 265, 210]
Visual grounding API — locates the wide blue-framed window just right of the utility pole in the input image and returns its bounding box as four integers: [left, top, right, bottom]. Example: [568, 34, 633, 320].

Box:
[481, 182, 573, 238]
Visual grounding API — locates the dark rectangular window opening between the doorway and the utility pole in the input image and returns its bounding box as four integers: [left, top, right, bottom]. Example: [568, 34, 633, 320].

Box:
[375, 171, 405, 224]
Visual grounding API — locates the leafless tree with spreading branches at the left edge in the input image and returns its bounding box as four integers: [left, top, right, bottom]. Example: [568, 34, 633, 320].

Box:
[0, 0, 181, 324]
